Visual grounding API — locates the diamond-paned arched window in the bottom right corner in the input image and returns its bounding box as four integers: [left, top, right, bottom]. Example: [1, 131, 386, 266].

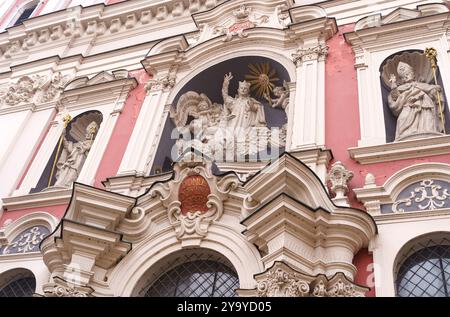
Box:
[396, 235, 450, 297]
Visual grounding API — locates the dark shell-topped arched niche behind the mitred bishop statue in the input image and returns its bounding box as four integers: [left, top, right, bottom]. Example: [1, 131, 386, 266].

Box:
[379, 50, 450, 143]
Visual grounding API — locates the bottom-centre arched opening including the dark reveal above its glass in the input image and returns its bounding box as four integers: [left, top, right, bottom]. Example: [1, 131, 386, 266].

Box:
[132, 248, 239, 297]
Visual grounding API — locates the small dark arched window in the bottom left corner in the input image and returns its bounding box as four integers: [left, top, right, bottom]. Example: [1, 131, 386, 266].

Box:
[0, 269, 36, 297]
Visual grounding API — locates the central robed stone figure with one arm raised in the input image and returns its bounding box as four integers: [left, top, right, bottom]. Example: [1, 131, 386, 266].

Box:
[222, 73, 267, 136]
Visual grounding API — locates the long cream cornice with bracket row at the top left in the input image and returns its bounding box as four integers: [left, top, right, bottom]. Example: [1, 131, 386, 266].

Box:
[0, 0, 229, 68]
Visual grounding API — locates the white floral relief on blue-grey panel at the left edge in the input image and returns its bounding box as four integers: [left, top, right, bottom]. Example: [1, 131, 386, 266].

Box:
[0, 226, 50, 255]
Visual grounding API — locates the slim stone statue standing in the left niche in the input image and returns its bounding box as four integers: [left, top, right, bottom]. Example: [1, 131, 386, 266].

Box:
[54, 121, 98, 187]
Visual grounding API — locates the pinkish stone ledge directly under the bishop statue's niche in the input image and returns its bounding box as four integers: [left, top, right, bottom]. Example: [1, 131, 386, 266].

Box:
[348, 135, 450, 164]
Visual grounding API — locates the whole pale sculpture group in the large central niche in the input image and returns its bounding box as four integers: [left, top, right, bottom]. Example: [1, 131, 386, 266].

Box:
[171, 73, 288, 160]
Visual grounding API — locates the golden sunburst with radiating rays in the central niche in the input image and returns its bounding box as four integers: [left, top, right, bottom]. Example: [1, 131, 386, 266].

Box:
[245, 62, 279, 99]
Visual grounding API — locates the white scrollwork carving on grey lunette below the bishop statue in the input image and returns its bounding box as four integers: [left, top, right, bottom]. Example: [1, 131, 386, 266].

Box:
[392, 179, 450, 213]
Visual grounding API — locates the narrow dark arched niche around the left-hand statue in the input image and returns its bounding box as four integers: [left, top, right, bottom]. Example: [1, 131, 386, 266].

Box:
[30, 110, 103, 193]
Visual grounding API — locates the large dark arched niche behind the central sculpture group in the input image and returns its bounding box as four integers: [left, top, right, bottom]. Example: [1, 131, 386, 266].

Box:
[150, 56, 291, 174]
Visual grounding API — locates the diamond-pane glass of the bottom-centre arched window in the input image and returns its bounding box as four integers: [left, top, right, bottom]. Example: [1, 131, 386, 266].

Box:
[144, 260, 239, 297]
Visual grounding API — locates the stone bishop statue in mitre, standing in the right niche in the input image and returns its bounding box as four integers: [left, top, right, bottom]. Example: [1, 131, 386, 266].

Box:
[388, 62, 443, 141]
